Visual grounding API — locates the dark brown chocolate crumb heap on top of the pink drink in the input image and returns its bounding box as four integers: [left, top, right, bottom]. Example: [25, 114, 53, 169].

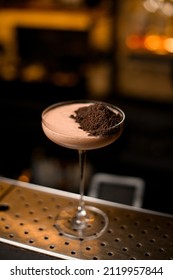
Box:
[70, 103, 121, 136]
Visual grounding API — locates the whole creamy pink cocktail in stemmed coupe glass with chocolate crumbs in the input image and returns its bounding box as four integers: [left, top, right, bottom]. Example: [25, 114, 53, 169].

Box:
[42, 101, 125, 240]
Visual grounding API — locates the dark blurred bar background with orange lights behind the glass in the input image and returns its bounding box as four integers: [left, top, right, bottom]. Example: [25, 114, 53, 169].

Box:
[0, 0, 173, 214]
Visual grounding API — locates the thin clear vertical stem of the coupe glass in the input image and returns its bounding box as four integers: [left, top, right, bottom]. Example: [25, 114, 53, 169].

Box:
[78, 150, 86, 212]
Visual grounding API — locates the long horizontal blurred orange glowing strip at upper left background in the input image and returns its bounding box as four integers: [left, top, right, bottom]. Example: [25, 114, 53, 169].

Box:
[0, 9, 92, 30]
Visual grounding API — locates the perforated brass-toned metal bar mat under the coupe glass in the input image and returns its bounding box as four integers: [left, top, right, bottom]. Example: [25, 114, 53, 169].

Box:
[0, 178, 173, 260]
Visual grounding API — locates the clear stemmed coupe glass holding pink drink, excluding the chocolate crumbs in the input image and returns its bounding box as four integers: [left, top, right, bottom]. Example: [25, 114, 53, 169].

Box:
[42, 100, 125, 240]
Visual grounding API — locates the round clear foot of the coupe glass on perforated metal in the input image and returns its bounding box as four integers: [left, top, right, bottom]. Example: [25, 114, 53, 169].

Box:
[55, 205, 108, 240]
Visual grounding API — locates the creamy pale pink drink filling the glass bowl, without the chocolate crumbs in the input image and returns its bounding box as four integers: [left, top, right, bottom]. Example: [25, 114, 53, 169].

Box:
[42, 103, 123, 150]
